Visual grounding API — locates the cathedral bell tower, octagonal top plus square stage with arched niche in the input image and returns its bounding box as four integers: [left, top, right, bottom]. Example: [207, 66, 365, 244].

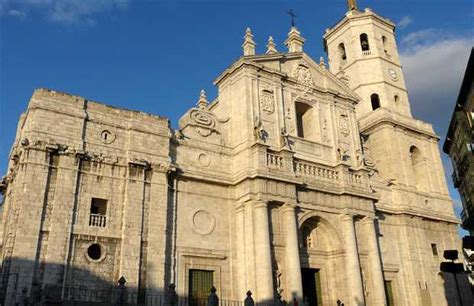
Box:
[324, 0, 449, 198]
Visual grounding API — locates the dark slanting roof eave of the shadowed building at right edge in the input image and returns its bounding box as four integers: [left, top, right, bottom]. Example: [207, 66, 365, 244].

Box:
[443, 47, 474, 155]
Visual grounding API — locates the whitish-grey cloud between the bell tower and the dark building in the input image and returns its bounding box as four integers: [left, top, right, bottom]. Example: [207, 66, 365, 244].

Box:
[400, 29, 474, 135]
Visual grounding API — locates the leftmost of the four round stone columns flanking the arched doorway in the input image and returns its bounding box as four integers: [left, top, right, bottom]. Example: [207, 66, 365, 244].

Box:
[254, 202, 273, 302]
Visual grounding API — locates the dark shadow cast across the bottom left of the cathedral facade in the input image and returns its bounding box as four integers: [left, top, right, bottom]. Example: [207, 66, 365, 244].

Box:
[0, 258, 286, 306]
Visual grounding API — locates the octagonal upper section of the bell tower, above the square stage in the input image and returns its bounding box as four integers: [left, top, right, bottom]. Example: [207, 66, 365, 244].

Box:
[324, 4, 411, 118]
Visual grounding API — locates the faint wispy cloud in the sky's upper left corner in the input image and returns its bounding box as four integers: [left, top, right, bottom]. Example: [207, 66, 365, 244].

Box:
[0, 0, 130, 25]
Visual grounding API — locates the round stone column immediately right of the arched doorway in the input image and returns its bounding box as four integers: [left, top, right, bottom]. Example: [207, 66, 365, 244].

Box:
[341, 215, 365, 306]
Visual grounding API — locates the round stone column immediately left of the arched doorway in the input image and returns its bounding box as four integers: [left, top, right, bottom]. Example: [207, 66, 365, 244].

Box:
[283, 204, 303, 300]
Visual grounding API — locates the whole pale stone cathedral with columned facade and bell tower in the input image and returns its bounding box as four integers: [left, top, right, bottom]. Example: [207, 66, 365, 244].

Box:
[0, 0, 470, 306]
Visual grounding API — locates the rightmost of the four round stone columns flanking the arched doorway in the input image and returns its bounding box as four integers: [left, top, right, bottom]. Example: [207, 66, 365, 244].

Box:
[363, 217, 387, 305]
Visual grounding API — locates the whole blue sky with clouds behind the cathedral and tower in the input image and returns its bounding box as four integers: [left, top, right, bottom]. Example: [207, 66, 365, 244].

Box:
[0, 0, 474, 233]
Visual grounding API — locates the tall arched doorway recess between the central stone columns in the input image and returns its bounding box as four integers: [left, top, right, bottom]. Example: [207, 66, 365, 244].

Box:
[299, 216, 346, 306]
